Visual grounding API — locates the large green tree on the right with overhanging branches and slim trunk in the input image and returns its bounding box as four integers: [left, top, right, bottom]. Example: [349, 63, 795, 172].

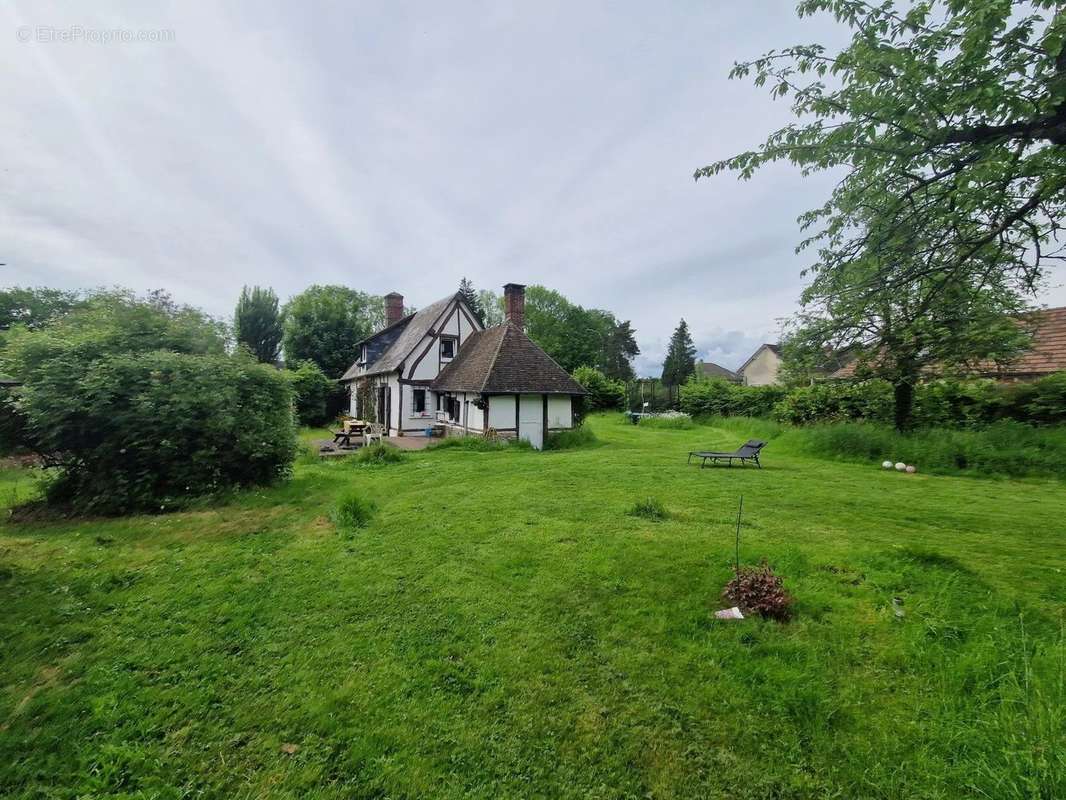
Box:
[696, 0, 1066, 430]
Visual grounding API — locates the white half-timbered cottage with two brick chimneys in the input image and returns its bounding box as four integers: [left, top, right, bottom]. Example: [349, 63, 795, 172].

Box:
[340, 284, 587, 449]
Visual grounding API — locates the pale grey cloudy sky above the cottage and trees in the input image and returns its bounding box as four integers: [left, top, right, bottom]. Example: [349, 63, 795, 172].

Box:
[0, 0, 1066, 373]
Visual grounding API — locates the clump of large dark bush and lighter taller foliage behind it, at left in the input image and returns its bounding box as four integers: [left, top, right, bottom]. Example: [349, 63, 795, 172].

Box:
[0, 291, 295, 513]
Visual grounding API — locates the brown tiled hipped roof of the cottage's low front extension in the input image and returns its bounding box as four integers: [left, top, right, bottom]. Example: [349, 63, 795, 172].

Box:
[430, 322, 588, 395]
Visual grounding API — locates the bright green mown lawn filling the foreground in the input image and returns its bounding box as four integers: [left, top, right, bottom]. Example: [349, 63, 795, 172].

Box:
[0, 416, 1066, 800]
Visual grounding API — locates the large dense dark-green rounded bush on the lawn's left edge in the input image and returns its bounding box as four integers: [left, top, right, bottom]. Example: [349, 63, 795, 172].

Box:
[12, 351, 296, 514]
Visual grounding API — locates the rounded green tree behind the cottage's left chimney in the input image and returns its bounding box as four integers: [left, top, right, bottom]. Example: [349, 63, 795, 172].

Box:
[282, 285, 385, 379]
